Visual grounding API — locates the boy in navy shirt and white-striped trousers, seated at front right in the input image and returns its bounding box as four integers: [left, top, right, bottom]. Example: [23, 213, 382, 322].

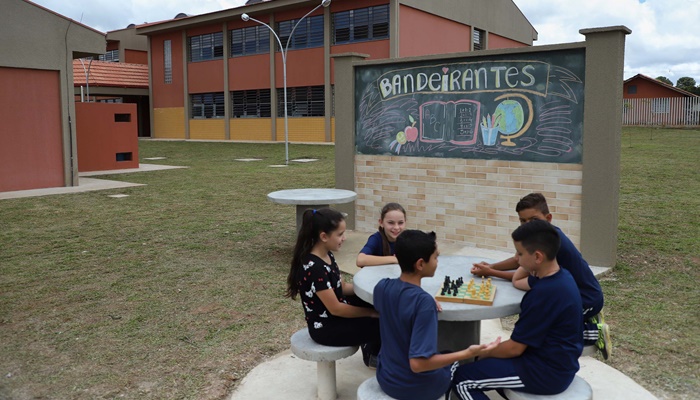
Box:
[453, 220, 583, 400]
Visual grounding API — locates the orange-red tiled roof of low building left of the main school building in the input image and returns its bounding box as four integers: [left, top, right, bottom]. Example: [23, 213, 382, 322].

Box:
[73, 60, 148, 89]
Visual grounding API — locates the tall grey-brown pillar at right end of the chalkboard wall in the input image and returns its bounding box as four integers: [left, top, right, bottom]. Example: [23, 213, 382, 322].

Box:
[579, 26, 632, 267]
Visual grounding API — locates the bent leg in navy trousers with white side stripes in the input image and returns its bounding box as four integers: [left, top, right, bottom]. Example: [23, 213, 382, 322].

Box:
[452, 358, 525, 400]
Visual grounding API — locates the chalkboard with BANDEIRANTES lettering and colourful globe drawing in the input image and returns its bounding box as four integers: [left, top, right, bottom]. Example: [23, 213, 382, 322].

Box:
[355, 49, 585, 163]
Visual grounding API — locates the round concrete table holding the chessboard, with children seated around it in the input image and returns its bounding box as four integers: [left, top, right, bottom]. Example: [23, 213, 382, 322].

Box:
[353, 255, 525, 351]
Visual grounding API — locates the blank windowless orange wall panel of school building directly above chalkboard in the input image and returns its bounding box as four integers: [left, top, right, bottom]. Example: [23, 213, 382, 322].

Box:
[399, 6, 471, 57]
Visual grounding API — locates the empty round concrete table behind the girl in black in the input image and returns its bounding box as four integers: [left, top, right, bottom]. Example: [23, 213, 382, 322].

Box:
[267, 188, 357, 232]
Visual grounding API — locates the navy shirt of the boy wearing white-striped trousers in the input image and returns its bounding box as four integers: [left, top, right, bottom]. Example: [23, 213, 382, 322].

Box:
[511, 268, 583, 393]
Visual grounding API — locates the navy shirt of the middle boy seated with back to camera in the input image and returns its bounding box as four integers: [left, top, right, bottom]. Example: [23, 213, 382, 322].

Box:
[374, 278, 450, 399]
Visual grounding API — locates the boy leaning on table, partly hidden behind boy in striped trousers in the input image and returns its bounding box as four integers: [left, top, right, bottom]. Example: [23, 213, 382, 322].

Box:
[471, 193, 612, 360]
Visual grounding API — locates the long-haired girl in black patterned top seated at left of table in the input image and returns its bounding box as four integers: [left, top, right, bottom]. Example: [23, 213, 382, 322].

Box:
[286, 208, 381, 368]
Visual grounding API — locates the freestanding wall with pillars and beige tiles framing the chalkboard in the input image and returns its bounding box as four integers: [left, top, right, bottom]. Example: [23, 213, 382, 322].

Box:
[335, 27, 631, 267]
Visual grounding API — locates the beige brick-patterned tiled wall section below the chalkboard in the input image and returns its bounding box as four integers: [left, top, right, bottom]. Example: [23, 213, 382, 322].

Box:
[355, 154, 582, 251]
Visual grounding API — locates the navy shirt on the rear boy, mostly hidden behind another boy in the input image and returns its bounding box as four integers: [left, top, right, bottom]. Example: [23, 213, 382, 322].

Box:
[555, 226, 604, 314]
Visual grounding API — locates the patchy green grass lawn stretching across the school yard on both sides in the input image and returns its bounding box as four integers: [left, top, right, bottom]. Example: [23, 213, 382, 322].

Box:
[0, 129, 700, 400]
